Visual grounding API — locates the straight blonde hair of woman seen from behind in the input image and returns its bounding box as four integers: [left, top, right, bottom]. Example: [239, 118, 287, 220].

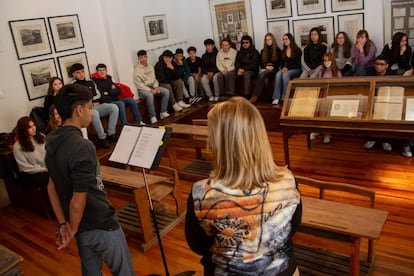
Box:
[207, 97, 280, 191]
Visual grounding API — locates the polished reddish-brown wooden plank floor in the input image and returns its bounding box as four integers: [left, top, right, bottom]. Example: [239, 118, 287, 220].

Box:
[0, 102, 414, 275]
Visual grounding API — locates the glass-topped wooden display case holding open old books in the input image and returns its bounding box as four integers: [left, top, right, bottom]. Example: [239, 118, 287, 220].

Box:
[280, 76, 414, 165]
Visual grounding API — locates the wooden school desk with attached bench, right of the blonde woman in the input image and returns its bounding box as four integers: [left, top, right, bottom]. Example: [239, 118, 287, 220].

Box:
[293, 176, 387, 275]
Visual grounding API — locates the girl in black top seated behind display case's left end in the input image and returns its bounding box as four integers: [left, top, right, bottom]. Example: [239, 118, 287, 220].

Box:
[300, 27, 328, 78]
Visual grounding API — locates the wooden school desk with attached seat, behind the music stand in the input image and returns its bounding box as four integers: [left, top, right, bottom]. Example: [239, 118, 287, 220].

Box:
[100, 166, 185, 251]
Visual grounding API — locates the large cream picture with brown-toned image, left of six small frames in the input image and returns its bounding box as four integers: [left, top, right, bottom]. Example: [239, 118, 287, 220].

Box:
[209, 0, 254, 48]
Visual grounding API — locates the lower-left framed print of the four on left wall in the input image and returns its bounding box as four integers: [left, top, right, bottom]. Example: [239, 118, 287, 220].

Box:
[20, 58, 57, 101]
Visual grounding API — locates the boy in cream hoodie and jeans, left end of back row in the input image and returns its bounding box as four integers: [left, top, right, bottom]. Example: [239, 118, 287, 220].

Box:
[134, 50, 170, 124]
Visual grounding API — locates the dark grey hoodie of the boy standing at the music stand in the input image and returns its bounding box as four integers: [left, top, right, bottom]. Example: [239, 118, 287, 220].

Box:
[46, 126, 119, 233]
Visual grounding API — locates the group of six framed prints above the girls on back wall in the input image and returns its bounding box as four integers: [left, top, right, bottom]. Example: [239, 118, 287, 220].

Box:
[265, 0, 364, 47]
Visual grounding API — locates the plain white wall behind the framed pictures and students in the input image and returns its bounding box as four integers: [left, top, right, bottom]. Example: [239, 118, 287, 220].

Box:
[0, 0, 384, 131]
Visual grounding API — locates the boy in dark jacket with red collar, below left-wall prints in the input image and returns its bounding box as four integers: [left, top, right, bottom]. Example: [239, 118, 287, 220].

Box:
[92, 63, 143, 125]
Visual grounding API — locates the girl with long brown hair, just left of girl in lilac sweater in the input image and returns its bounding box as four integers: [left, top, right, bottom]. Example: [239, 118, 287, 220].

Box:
[331, 32, 354, 77]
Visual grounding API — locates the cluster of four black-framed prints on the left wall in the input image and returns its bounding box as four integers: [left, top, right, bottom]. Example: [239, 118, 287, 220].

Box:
[9, 14, 89, 100]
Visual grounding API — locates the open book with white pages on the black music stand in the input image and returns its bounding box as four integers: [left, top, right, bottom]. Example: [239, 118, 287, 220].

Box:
[109, 125, 166, 169]
